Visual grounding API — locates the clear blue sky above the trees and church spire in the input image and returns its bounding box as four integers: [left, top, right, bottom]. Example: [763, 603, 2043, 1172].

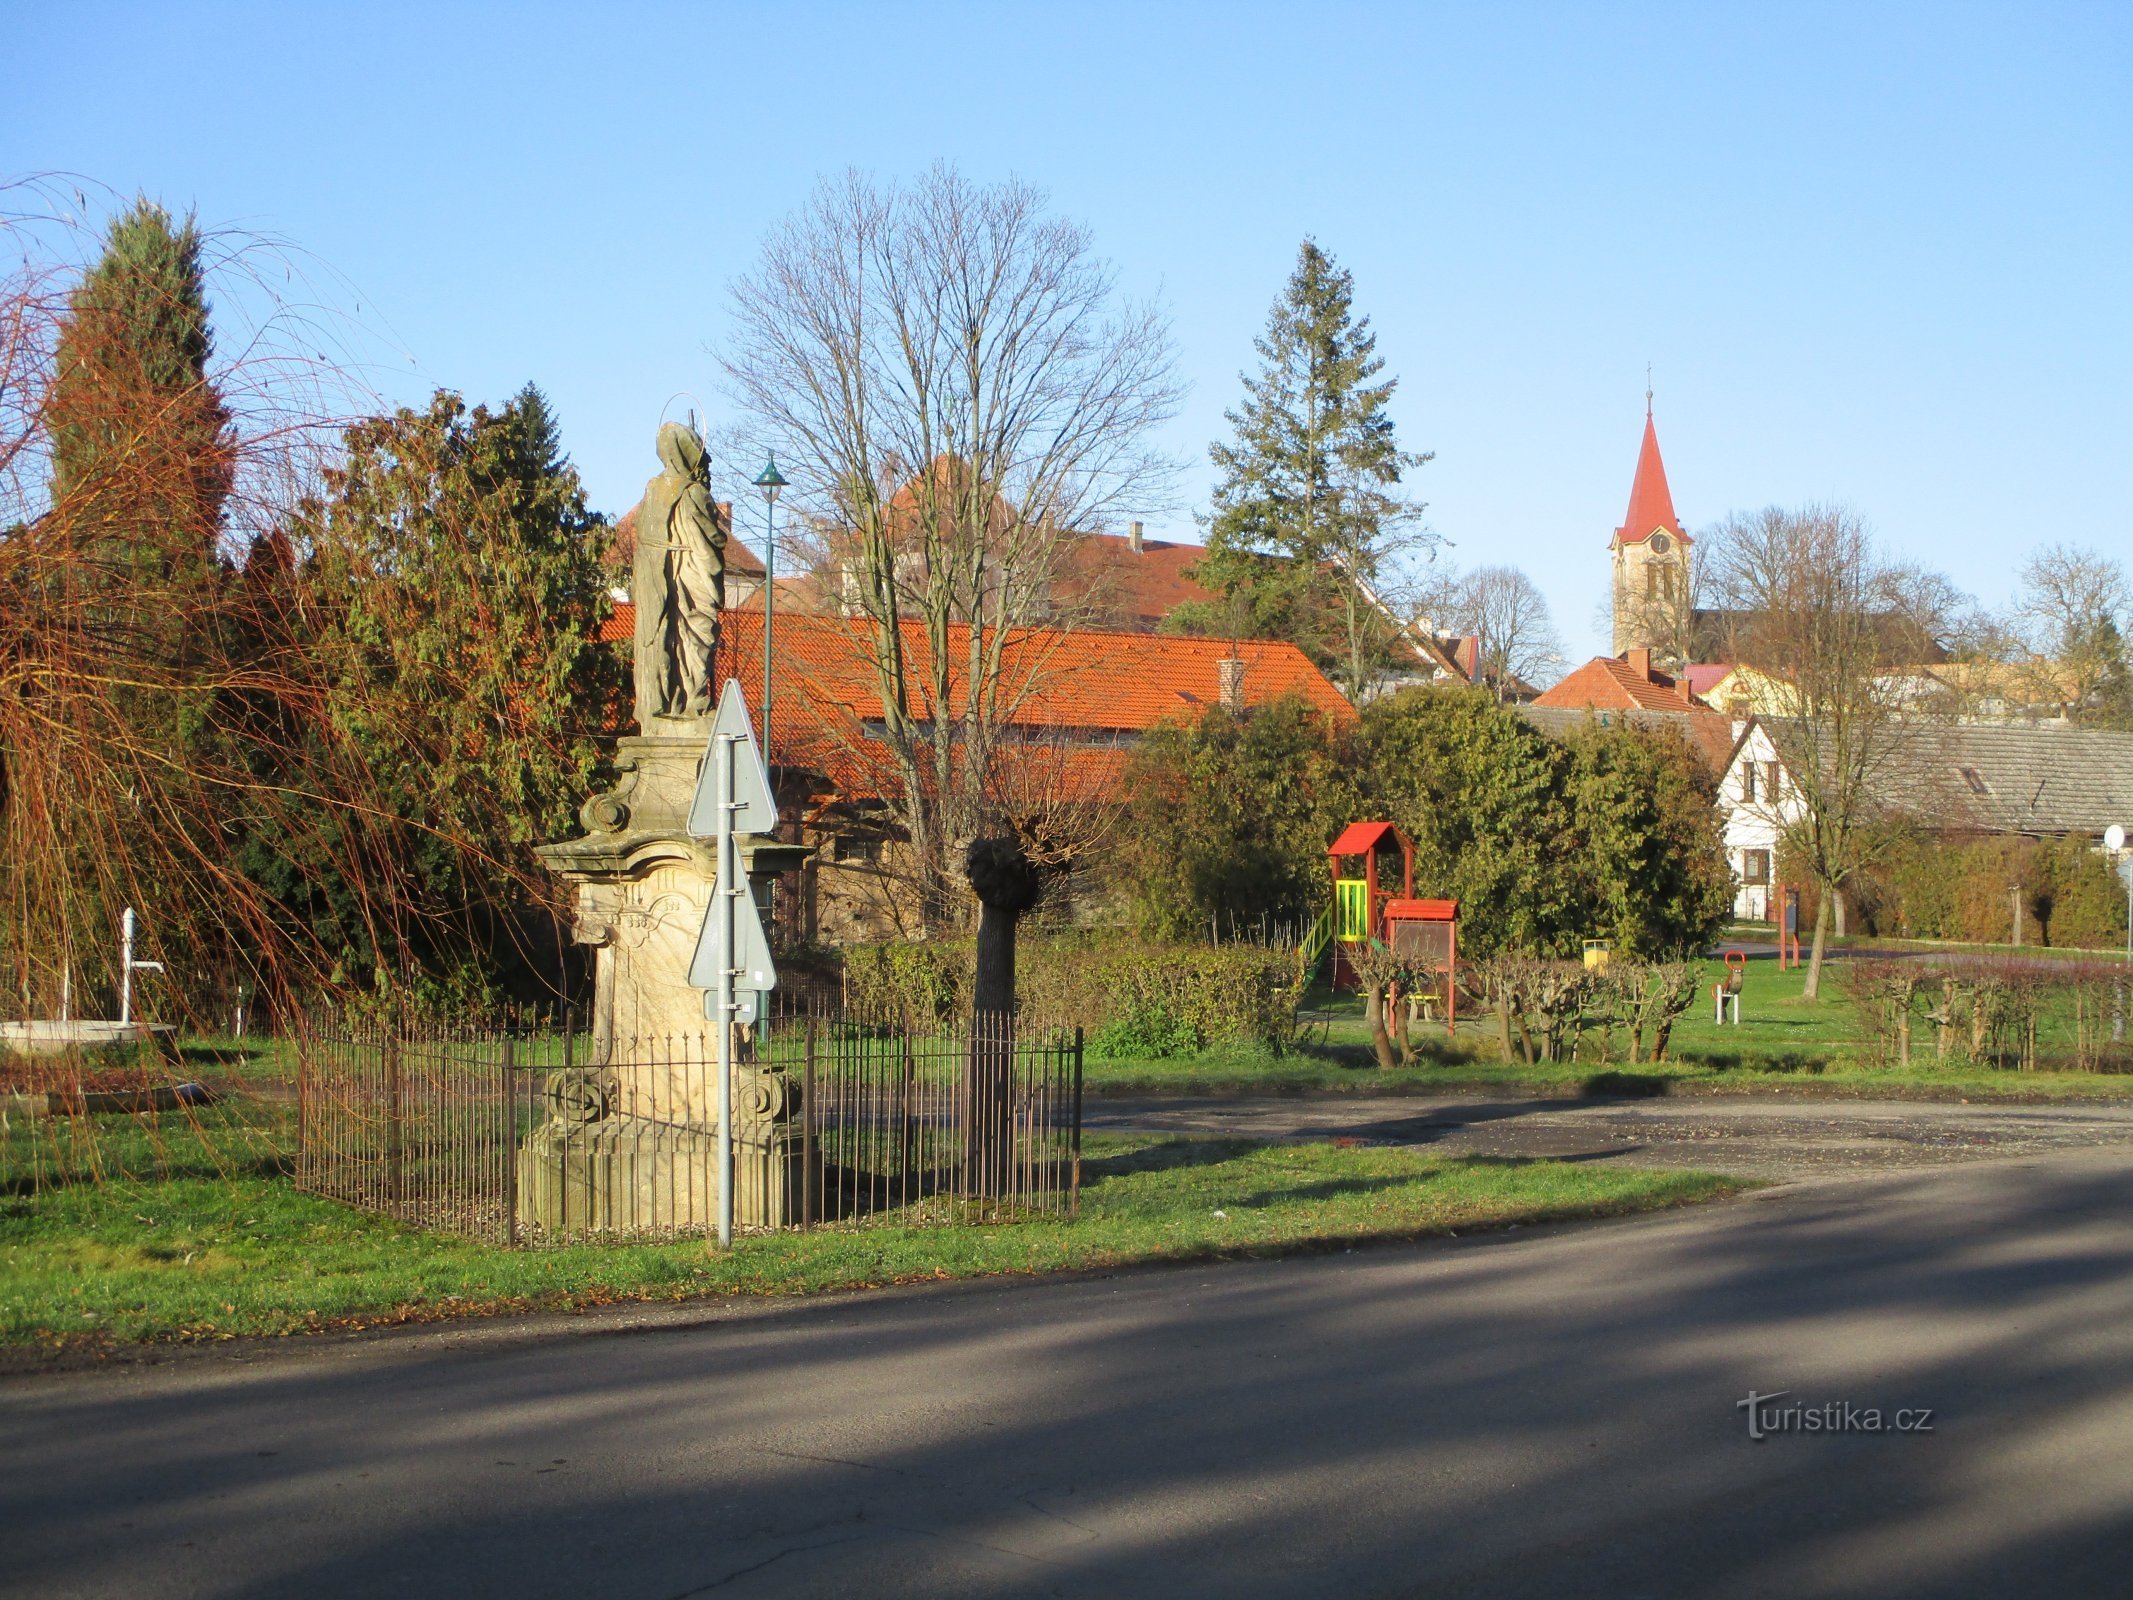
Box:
[0, 0, 2133, 659]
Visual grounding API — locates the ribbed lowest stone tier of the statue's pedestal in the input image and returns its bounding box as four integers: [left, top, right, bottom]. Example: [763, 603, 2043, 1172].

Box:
[518, 1116, 821, 1233]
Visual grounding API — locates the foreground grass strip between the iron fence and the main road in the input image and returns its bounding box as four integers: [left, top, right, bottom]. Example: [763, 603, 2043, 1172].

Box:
[0, 1103, 1743, 1346]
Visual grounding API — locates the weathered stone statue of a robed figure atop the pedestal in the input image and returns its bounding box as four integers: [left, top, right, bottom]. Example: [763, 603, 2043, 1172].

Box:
[629, 422, 725, 736]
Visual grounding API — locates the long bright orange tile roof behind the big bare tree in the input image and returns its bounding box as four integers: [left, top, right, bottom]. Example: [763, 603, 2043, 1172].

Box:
[599, 602, 1354, 798]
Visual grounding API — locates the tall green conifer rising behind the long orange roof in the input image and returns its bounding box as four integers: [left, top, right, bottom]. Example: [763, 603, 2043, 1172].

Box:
[1190, 239, 1429, 695]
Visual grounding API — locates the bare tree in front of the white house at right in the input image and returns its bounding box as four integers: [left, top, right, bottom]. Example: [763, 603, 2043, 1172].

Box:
[1709, 506, 1960, 998]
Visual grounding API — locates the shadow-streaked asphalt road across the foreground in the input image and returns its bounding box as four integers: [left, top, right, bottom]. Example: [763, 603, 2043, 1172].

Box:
[0, 1148, 2133, 1600]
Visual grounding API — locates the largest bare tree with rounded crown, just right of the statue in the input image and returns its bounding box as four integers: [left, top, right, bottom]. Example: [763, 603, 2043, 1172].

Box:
[723, 166, 1180, 919]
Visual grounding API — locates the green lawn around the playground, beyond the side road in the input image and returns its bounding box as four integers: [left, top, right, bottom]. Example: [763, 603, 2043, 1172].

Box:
[1086, 960, 2133, 1099]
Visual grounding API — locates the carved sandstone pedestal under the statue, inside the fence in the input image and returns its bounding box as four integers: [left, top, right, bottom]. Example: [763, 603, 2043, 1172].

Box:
[518, 719, 806, 1231]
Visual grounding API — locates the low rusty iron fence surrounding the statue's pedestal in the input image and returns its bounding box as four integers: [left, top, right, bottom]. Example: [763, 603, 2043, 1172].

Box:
[296, 1009, 1081, 1244]
